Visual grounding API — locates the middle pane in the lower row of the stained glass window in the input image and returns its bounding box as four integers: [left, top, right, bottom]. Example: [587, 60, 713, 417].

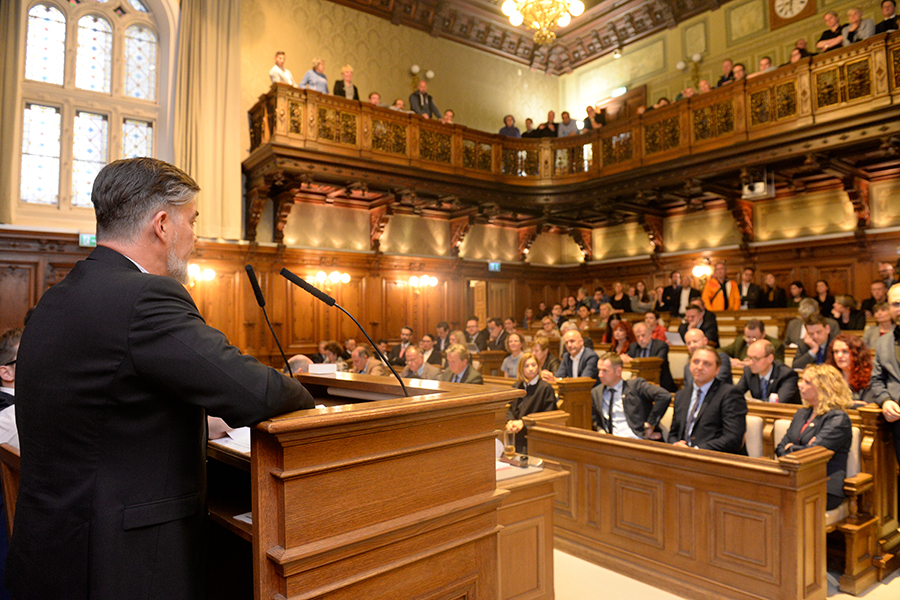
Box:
[72, 111, 109, 206]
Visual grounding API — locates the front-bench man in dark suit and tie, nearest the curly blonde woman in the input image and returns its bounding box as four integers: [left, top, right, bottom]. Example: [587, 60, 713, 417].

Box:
[668, 346, 747, 454]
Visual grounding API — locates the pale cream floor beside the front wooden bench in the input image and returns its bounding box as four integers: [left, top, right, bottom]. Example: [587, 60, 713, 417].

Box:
[553, 550, 900, 600]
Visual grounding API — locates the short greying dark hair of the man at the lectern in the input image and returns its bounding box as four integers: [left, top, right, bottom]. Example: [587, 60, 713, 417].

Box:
[91, 158, 200, 242]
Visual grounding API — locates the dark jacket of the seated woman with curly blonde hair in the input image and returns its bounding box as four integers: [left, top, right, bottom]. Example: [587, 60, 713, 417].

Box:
[775, 406, 853, 509]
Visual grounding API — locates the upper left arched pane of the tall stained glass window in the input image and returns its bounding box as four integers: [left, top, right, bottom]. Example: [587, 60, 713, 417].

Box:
[25, 4, 66, 85]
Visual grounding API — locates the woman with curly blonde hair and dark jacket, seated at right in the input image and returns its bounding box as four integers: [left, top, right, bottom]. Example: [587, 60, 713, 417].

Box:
[775, 365, 853, 510]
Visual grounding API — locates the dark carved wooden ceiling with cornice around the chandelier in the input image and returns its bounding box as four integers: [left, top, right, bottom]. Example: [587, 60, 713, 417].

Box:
[331, 0, 727, 75]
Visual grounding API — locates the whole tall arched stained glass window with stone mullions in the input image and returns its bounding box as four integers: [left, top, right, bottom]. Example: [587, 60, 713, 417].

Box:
[19, 0, 160, 211]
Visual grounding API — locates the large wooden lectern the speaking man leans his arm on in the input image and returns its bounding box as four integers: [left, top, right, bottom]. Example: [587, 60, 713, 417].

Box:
[209, 373, 523, 600]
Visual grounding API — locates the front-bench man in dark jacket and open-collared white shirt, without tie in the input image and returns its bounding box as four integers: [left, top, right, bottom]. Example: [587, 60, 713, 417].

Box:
[591, 352, 672, 440]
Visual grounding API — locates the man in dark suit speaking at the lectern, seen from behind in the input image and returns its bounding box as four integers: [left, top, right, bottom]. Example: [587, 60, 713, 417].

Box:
[7, 158, 314, 600]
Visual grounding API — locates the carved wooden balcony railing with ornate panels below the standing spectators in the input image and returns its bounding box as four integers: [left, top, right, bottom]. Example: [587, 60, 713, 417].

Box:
[249, 33, 900, 186]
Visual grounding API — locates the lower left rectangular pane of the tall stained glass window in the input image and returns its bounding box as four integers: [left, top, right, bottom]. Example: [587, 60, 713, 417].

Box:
[21, 104, 60, 204]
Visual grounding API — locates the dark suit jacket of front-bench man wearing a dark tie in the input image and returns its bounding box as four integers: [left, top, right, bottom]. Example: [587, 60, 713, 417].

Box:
[669, 379, 747, 454]
